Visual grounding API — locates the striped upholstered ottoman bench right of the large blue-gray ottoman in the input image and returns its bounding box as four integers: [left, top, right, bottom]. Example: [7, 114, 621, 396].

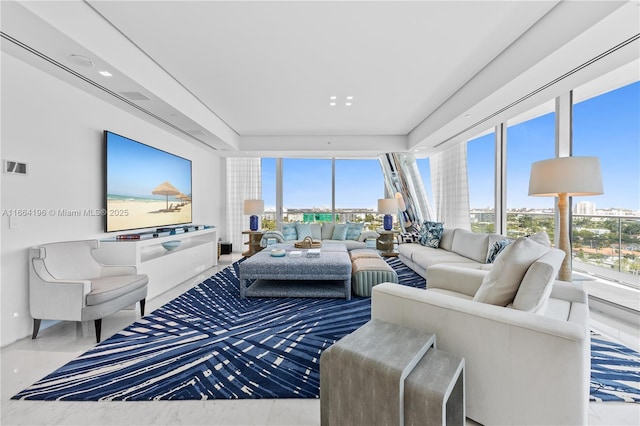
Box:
[350, 249, 398, 297]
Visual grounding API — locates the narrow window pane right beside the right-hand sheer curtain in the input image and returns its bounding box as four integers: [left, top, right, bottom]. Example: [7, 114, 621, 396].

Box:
[467, 132, 496, 232]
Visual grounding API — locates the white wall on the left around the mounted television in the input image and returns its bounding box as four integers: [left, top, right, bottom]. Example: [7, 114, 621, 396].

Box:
[0, 53, 226, 346]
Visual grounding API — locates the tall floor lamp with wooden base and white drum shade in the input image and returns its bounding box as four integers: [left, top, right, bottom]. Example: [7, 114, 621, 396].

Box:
[529, 157, 603, 281]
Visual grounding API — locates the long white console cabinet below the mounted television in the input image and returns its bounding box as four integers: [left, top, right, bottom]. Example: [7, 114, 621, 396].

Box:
[94, 228, 218, 299]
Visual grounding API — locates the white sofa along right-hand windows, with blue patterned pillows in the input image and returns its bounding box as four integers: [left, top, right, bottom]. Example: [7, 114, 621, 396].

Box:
[398, 228, 505, 278]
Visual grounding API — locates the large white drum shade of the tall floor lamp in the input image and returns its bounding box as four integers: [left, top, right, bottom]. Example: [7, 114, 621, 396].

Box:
[529, 157, 604, 197]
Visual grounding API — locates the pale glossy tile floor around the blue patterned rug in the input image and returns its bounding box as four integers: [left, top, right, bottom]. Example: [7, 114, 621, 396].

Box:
[0, 255, 640, 426]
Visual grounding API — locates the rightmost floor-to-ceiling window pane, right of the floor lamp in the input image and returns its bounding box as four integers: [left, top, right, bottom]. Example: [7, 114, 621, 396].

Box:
[572, 82, 640, 283]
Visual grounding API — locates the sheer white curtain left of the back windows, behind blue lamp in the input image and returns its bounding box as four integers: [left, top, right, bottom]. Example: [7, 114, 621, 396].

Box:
[227, 158, 262, 252]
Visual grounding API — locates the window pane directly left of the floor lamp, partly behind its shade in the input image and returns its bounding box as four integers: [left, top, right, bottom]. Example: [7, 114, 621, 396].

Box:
[506, 113, 555, 241]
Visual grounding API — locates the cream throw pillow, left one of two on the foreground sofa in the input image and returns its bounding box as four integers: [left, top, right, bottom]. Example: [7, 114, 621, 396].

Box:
[473, 237, 550, 306]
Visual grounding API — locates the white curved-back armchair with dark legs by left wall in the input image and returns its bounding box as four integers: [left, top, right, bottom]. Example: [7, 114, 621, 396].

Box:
[29, 240, 149, 342]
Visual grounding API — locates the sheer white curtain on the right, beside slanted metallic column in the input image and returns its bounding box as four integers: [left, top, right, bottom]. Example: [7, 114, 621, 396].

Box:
[429, 143, 471, 229]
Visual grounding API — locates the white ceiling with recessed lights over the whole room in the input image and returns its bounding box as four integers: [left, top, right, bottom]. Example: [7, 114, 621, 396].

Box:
[2, 0, 640, 156]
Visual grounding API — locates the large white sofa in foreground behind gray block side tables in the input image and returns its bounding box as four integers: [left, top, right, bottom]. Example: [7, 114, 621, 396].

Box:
[371, 238, 590, 425]
